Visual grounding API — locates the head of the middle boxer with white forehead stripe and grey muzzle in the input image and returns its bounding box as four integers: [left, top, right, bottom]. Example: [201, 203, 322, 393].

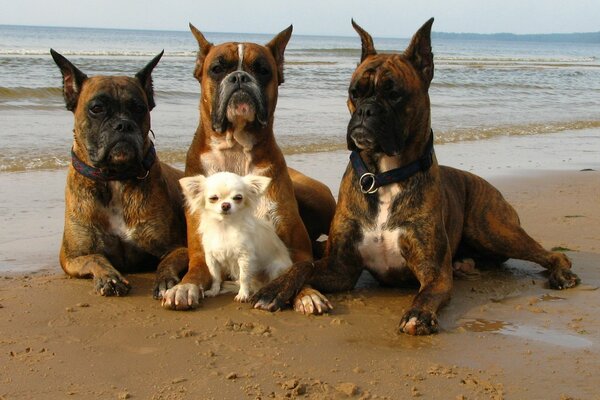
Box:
[190, 24, 292, 141]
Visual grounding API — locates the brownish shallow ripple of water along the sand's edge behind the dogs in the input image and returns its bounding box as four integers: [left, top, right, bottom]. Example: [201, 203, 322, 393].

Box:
[0, 120, 600, 172]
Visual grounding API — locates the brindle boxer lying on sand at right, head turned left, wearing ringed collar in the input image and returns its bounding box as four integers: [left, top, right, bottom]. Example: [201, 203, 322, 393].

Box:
[253, 18, 579, 335]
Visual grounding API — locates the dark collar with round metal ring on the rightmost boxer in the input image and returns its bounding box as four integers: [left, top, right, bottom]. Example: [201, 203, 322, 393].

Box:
[350, 130, 434, 194]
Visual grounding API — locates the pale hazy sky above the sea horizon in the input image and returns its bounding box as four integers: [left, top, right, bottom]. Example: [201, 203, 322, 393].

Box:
[0, 0, 600, 37]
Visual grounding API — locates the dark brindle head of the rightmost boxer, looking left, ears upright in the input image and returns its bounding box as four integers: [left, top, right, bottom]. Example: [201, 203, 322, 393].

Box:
[346, 18, 433, 156]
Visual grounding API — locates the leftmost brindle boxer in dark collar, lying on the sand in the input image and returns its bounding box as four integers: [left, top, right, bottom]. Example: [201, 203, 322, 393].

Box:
[50, 50, 187, 296]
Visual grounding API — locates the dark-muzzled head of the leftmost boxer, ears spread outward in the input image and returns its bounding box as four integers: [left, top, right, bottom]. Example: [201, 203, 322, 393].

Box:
[50, 49, 163, 173]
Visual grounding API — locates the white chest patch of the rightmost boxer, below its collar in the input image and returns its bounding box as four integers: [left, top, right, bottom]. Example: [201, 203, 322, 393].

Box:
[358, 185, 406, 276]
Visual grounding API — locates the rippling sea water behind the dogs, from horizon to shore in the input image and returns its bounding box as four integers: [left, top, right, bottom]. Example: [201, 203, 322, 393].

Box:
[0, 26, 600, 173]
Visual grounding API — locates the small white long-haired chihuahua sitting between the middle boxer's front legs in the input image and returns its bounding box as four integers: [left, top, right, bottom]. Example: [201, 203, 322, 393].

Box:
[179, 172, 292, 302]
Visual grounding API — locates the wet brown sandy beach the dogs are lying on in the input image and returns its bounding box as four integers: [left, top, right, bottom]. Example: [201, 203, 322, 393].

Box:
[0, 131, 600, 400]
